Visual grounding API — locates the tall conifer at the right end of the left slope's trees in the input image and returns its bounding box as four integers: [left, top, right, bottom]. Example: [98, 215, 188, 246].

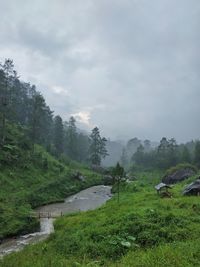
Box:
[89, 127, 108, 166]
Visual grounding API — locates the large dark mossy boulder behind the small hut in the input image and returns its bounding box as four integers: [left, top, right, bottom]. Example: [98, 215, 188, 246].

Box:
[162, 168, 195, 184]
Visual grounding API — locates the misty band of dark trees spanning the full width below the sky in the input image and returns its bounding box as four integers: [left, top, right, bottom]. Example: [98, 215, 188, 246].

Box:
[0, 59, 200, 174]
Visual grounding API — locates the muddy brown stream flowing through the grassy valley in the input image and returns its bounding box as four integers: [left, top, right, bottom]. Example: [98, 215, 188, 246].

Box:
[0, 185, 112, 257]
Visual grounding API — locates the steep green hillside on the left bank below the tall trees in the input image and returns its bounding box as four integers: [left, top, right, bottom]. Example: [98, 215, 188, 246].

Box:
[0, 125, 101, 239]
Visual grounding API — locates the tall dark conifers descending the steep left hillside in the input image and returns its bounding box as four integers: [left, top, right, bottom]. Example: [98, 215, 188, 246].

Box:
[0, 59, 107, 165]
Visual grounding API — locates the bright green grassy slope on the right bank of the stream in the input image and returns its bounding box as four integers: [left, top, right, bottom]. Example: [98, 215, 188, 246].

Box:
[0, 173, 200, 267]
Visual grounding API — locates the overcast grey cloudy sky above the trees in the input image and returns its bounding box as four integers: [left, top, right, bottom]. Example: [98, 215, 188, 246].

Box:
[0, 0, 200, 142]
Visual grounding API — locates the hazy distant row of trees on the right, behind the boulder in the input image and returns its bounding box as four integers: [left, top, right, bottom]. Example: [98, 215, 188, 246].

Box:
[121, 137, 200, 169]
